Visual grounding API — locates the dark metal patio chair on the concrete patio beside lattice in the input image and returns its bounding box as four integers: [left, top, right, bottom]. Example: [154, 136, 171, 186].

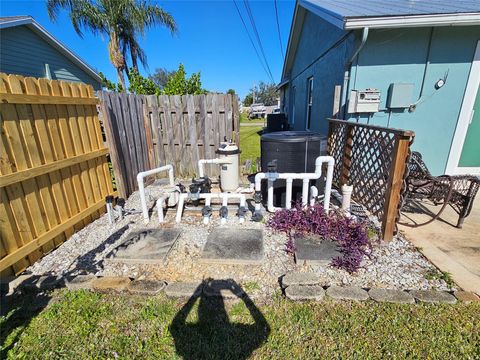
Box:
[401, 151, 480, 228]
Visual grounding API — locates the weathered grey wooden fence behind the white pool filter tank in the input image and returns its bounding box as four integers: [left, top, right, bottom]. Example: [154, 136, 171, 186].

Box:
[100, 92, 240, 197]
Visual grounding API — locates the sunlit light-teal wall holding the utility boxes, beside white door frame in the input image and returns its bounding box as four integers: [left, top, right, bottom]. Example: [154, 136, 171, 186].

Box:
[348, 26, 480, 174]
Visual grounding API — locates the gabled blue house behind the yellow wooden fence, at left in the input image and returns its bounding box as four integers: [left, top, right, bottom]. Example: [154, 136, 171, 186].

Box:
[0, 16, 102, 90]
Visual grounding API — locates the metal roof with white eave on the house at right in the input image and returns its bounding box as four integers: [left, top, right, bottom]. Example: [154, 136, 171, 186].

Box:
[298, 0, 480, 29]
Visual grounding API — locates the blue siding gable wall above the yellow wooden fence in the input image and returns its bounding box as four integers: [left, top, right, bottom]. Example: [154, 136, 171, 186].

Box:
[0, 26, 101, 90]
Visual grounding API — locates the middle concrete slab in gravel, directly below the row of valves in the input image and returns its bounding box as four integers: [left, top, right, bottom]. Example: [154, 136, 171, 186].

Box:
[201, 228, 263, 265]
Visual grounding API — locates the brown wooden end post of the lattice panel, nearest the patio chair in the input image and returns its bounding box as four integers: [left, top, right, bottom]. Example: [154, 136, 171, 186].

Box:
[382, 134, 411, 241]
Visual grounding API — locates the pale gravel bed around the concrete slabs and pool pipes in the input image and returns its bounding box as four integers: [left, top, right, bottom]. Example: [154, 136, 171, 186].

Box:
[27, 185, 449, 297]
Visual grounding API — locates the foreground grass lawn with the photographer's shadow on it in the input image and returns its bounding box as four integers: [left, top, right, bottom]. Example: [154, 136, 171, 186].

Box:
[0, 290, 480, 360]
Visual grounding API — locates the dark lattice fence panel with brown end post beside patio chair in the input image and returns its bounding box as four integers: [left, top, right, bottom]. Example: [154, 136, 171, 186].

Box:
[328, 119, 415, 240]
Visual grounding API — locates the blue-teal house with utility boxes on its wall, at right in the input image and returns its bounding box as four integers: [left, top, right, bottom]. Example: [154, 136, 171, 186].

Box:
[280, 0, 480, 174]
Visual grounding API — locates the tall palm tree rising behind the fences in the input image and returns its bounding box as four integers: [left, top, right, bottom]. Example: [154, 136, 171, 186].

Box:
[47, 0, 177, 90]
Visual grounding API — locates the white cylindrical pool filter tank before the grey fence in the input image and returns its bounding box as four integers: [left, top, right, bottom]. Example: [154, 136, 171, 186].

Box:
[216, 141, 240, 192]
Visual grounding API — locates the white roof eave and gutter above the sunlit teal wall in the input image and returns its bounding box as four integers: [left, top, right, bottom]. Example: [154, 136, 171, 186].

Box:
[344, 13, 480, 30]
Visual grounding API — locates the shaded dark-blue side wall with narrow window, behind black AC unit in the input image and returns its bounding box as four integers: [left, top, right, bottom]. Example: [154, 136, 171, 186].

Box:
[287, 12, 355, 134]
